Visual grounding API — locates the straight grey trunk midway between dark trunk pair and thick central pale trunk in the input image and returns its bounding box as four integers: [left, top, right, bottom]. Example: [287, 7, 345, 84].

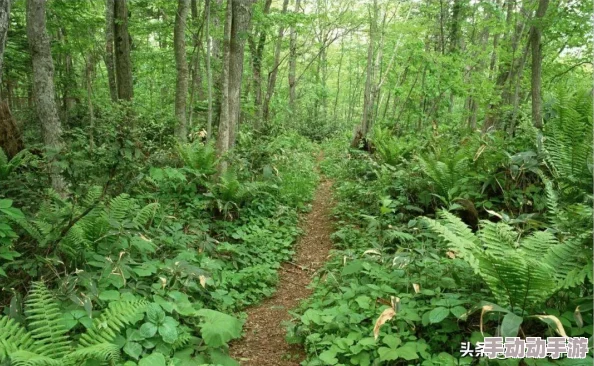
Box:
[173, 0, 190, 142]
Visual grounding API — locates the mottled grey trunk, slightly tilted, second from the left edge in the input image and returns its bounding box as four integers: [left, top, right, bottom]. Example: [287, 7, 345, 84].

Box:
[27, 0, 66, 195]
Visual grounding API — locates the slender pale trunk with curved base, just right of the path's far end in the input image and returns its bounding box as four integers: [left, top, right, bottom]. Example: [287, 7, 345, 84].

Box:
[351, 0, 377, 148]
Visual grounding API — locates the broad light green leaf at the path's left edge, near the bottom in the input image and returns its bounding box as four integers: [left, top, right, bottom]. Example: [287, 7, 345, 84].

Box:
[196, 309, 243, 347]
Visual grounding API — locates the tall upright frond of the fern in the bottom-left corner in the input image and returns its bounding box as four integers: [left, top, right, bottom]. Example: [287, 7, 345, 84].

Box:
[25, 282, 70, 359]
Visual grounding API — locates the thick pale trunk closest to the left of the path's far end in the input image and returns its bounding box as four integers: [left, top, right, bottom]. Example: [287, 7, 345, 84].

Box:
[229, 0, 253, 148]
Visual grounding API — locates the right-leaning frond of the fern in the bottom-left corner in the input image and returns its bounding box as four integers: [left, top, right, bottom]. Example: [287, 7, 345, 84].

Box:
[79, 300, 147, 347]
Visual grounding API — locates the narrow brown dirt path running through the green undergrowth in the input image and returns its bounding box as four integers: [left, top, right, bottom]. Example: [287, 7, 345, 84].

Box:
[230, 154, 333, 366]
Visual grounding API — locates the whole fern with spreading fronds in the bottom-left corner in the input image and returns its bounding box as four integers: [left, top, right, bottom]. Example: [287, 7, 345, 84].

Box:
[0, 282, 146, 366]
